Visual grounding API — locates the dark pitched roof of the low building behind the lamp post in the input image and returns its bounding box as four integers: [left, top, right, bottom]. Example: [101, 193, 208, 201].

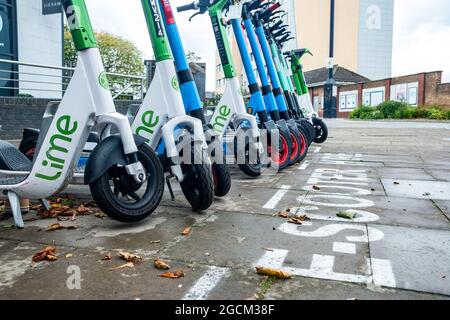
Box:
[305, 65, 370, 87]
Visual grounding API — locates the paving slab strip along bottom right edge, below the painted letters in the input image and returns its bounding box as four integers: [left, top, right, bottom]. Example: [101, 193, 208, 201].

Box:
[266, 278, 450, 300]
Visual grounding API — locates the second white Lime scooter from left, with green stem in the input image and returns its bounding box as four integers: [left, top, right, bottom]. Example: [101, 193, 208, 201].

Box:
[129, 0, 214, 211]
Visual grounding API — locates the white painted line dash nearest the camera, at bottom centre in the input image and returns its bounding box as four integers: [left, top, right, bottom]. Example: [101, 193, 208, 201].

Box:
[183, 266, 230, 300]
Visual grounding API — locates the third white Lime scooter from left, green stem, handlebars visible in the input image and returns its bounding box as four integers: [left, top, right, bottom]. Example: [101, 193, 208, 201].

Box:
[177, 0, 268, 177]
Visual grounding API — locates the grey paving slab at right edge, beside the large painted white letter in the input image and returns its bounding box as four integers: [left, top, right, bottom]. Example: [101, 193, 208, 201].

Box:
[370, 225, 450, 295]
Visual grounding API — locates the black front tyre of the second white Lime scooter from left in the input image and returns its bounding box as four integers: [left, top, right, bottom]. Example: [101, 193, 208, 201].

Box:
[180, 148, 214, 211]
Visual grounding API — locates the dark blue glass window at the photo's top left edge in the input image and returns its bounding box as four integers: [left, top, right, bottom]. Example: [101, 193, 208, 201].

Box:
[0, 0, 17, 96]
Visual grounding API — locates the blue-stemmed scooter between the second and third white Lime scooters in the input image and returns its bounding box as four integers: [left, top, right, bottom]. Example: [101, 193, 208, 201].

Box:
[158, 0, 231, 197]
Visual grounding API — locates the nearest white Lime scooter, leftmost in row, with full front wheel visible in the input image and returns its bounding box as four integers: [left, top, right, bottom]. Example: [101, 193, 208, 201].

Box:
[0, 0, 164, 228]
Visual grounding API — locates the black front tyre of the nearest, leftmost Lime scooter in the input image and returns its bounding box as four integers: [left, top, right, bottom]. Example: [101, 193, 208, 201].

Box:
[89, 144, 164, 222]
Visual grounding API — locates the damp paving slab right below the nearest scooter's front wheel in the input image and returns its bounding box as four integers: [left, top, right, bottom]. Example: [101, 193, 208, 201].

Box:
[0, 207, 202, 256]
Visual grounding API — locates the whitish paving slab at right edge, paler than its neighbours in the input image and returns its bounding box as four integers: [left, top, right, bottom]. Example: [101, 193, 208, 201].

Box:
[381, 179, 450, 200]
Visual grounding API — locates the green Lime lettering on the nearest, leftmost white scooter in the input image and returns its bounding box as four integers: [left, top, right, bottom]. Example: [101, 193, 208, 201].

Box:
[36, 115, 78, 181]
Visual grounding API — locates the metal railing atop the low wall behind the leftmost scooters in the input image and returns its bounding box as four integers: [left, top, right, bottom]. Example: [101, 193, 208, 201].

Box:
[0, 59, 145, 100]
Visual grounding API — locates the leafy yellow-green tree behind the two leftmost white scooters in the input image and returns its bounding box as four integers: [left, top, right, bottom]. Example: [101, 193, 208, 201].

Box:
[64, 27, 144, 95]
